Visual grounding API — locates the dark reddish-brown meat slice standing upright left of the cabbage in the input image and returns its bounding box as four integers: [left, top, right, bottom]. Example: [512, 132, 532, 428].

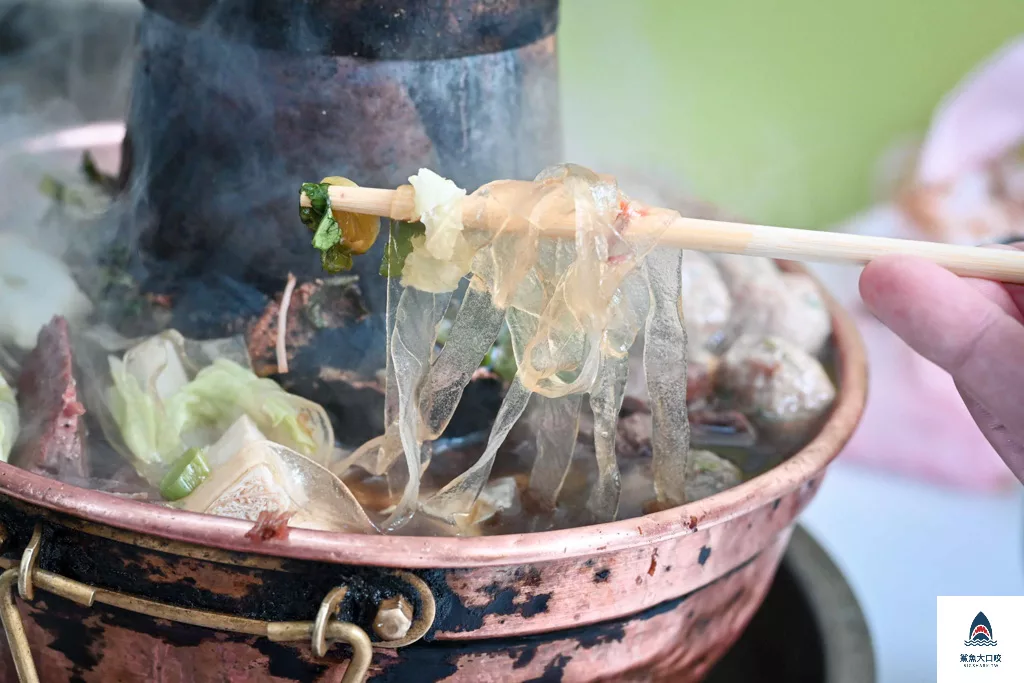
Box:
[10, 315, 90, 480]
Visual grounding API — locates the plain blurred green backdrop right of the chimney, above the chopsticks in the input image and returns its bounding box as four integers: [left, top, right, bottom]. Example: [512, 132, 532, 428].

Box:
[559, 0, 1024, 228]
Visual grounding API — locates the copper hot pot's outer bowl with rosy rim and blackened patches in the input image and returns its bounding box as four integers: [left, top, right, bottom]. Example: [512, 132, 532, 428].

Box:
[0, 259, 866, 683]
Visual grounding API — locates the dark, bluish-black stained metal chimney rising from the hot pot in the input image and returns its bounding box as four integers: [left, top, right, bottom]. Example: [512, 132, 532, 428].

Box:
[122, 0, 561, 438]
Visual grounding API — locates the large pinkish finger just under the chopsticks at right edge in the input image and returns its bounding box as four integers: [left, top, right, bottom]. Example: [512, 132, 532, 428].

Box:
[860, 256, 1024, 458]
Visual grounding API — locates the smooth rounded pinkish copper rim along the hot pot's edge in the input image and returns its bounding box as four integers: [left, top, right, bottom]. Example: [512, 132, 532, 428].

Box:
[0, 218, 867, 568]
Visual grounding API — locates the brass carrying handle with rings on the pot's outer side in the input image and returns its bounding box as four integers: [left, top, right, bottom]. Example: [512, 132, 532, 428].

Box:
[0, 523, 436, 683]
